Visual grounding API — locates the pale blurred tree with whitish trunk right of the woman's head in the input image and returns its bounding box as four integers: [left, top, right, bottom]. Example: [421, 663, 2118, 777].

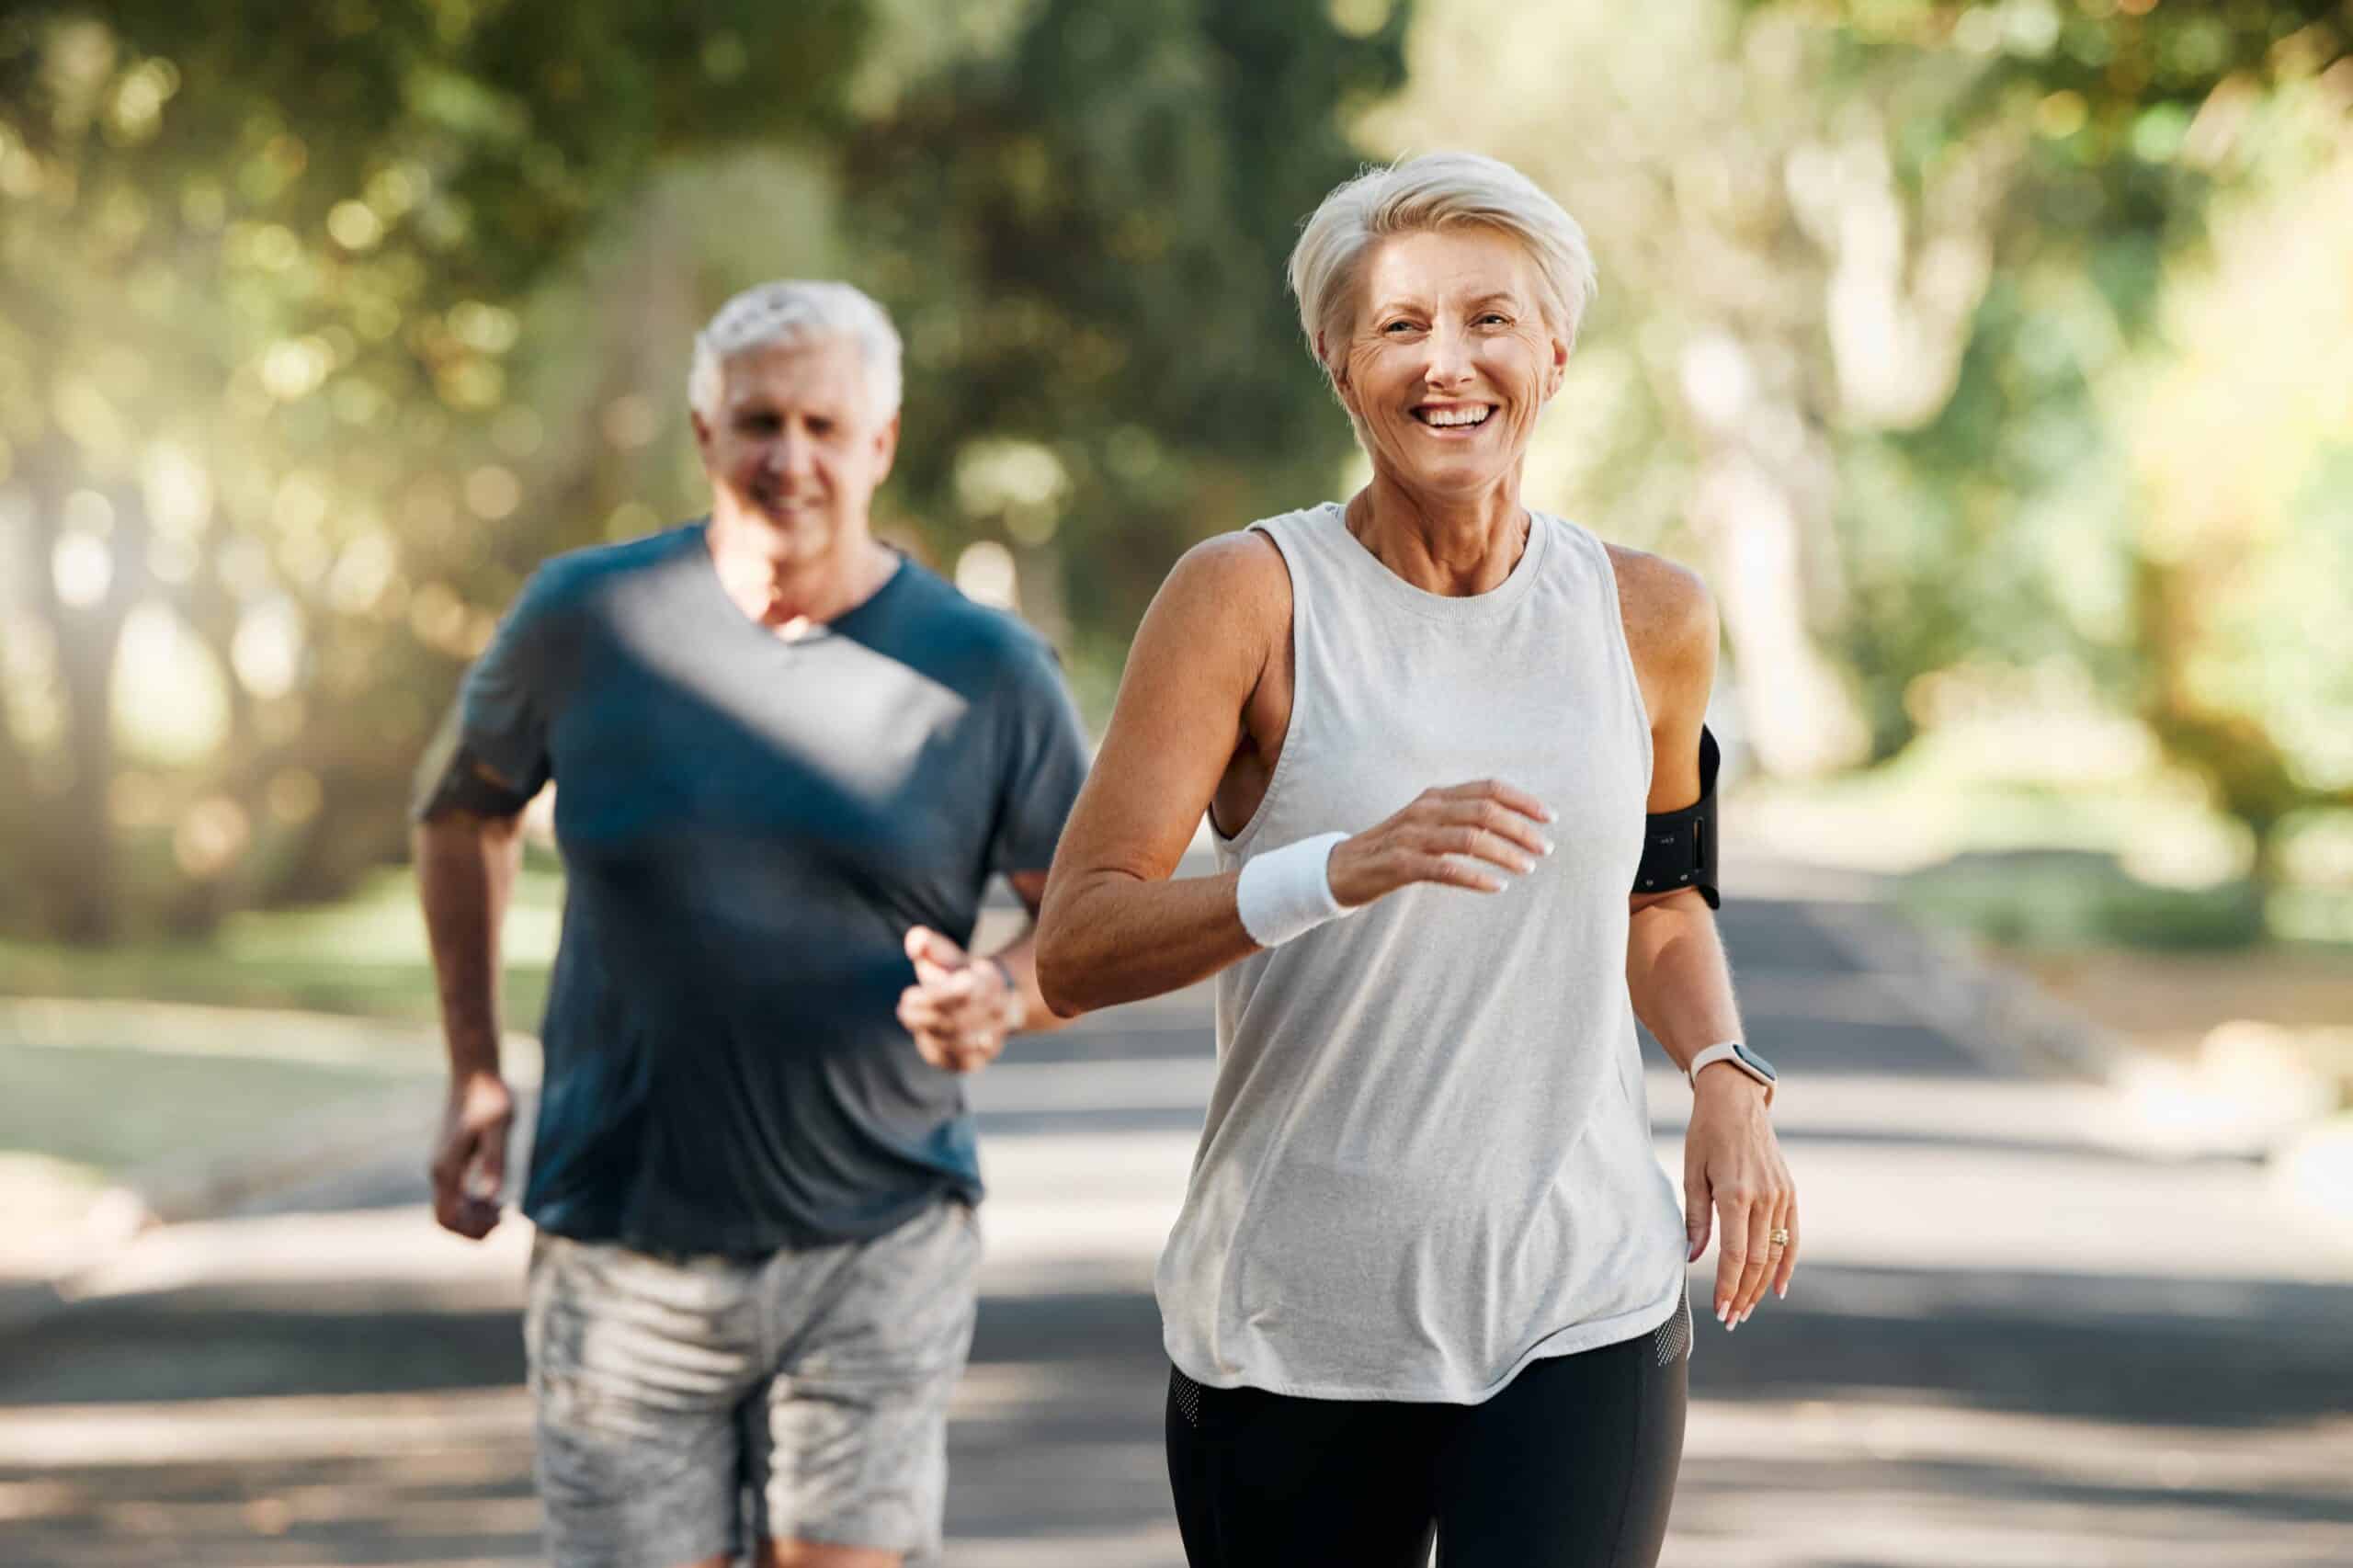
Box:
[1365, 0, 1929, 775]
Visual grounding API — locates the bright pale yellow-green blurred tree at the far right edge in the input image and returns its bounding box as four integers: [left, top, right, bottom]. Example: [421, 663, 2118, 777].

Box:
[2115, 139, 2353, 878]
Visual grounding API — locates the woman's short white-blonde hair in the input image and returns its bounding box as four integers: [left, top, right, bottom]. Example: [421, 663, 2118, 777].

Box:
[1290, 153, 1600, 374]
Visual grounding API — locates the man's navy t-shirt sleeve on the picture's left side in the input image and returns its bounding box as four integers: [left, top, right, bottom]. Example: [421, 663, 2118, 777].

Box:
[409, 572, 555, 822]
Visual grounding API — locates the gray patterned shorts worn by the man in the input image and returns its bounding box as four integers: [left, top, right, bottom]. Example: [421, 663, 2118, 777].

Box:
[522, 1199, 982, 1568]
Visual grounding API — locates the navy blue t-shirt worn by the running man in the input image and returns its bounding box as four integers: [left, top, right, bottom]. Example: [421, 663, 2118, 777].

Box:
[416, 523, 1087, 1255]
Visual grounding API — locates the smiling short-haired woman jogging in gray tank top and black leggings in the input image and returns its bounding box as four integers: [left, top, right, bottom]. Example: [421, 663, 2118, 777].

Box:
[1038, 153, 1798, 1568]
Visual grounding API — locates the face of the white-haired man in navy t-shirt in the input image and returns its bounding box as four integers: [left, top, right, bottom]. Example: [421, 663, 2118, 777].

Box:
[694, 336, 899, 565]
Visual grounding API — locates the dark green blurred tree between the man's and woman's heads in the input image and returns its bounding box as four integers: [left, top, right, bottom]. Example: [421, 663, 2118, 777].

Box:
[842, 0, 1404, 692]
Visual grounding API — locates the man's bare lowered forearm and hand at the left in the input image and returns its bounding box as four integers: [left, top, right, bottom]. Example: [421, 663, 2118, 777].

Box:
[412, 808, 522, 1241]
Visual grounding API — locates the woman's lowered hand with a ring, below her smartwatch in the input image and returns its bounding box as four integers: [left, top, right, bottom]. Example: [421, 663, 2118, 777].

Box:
[1682, 1062, 1798, 1328]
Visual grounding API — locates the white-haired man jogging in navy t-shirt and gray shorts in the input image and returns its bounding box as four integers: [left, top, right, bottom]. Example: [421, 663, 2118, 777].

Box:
[416, 282, 1087, 1568]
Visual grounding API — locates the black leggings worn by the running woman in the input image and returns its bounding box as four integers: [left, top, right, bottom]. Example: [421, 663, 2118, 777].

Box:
[1167, 1307, 1692, 1568]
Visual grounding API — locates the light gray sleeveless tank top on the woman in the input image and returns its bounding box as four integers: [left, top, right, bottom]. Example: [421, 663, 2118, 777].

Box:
[1155, 504, 1685, 1403]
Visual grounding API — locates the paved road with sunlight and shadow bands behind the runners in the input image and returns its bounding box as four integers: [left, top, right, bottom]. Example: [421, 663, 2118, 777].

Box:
[0, 881, 2353, 1568]
